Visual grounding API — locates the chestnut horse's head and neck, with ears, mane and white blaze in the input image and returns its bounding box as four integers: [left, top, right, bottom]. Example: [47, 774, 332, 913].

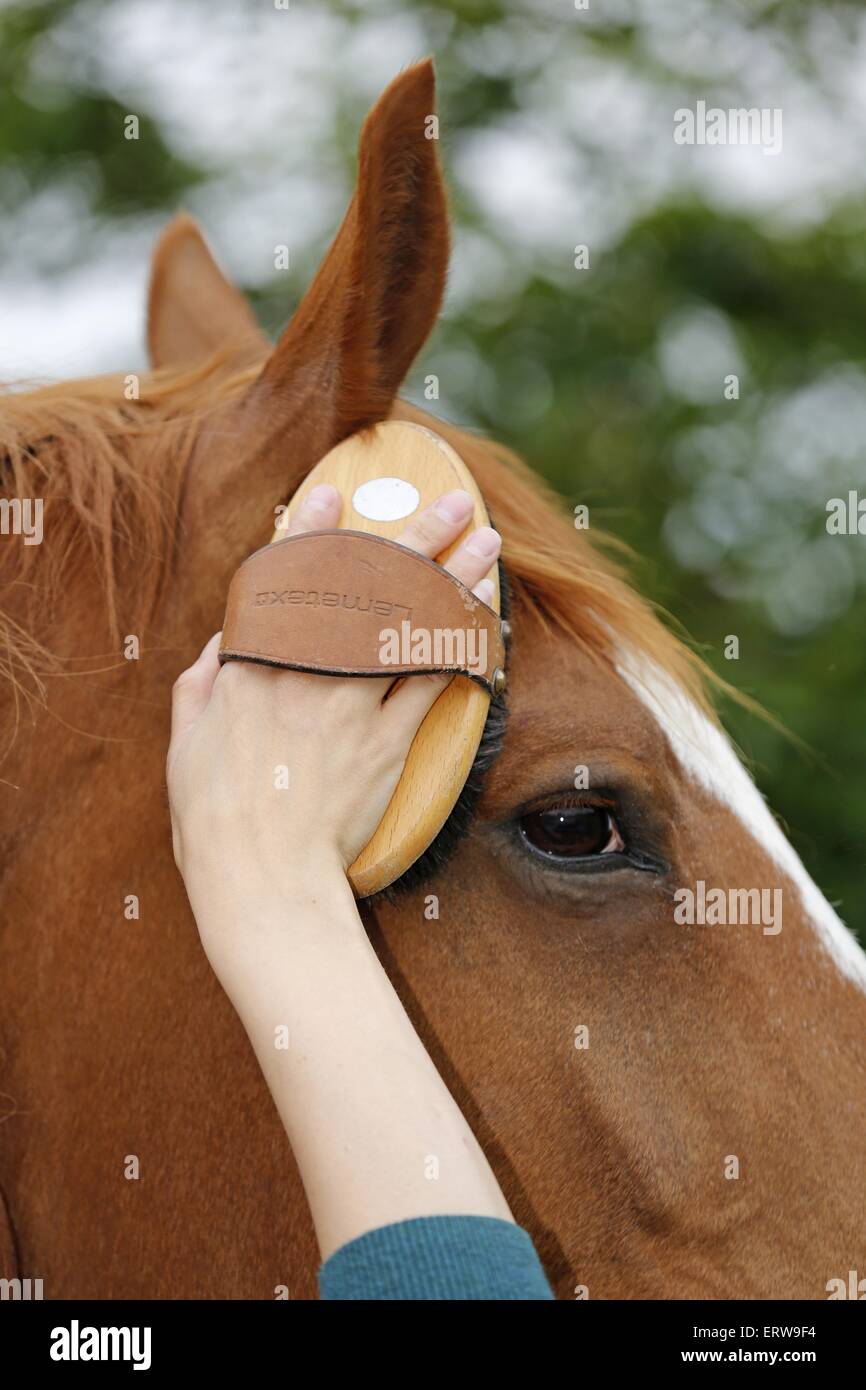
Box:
[0, 64, 866, 1298]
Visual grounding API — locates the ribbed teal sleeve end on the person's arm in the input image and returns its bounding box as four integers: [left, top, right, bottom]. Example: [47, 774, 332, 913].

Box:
[318, 1216, 553, 1302]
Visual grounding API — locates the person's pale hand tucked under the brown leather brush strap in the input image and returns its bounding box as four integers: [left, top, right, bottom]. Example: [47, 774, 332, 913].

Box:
[167, 484, 500, 906]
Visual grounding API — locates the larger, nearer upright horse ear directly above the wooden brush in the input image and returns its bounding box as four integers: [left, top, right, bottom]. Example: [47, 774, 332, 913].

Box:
[248, 60, 449, 446]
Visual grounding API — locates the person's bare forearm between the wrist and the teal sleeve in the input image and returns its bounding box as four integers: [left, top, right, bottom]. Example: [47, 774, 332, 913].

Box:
[186, 870, 510, 1259]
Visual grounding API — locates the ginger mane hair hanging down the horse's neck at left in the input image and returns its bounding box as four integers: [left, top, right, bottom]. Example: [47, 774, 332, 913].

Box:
[0, 359, 242, 708]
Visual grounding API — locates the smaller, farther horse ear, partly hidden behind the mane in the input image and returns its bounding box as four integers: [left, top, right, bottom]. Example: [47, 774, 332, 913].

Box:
[147, 213, 270, 367]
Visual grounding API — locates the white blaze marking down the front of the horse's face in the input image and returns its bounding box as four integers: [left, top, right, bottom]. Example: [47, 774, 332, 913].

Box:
[617, 653, 866, 990]
